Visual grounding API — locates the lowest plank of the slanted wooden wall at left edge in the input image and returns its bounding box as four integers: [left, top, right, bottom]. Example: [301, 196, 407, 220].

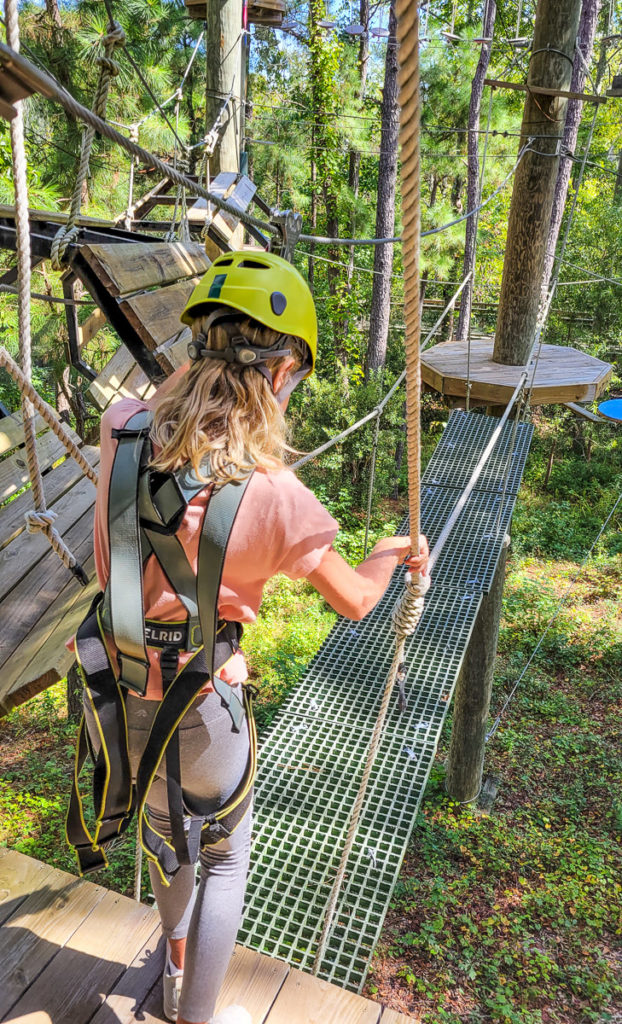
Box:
[0, 542, 99, 714]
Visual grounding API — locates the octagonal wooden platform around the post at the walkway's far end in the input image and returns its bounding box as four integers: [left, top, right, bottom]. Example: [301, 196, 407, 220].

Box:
[421, 338, 613, 406]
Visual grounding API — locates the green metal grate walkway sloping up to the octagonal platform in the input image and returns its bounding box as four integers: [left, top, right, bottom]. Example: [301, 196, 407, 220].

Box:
[239, 412, 532, 990]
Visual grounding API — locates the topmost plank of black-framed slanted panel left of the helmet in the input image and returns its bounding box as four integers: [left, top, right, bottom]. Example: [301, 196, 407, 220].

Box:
[81, 242, 210, 296]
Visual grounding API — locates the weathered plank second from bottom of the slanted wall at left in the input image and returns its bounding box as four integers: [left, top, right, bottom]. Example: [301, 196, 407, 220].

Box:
[0, 509, 93, 687]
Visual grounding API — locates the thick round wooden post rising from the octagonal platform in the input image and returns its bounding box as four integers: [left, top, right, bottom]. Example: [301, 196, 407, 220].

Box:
[493, 0, 581, 366]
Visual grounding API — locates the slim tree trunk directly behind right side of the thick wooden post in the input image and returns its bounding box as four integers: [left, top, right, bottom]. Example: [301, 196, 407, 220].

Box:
[541, 0, 600, 302]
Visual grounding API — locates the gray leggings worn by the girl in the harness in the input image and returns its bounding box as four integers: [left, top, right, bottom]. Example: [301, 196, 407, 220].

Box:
[88, 693, 251, 1022]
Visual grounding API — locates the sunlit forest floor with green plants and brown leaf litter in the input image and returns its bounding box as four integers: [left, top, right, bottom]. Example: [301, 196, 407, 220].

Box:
[0, 411, 622, 1024]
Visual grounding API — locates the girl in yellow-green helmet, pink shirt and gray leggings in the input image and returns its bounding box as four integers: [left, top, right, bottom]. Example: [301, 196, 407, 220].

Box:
[95, 251, 427, 1024]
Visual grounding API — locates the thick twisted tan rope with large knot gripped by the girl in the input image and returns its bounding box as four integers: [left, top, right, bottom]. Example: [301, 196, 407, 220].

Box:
[313, 0, 429, 974]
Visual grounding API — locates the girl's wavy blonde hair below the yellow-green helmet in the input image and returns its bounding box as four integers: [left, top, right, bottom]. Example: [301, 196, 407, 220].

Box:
[151, 309, 302, 483]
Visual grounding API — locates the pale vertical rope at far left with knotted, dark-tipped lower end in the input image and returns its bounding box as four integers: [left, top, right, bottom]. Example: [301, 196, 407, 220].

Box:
[4, 0, 88, 584]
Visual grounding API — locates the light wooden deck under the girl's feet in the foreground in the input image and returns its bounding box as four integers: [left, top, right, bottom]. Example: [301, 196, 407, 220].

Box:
[0, 849, 414, 1024]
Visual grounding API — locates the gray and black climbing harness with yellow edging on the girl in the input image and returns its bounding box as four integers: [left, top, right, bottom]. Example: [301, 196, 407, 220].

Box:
[67, 411, 256, 884]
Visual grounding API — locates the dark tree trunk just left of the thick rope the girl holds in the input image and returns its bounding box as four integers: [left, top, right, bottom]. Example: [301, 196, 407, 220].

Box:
[366, 0, 400, 376]
